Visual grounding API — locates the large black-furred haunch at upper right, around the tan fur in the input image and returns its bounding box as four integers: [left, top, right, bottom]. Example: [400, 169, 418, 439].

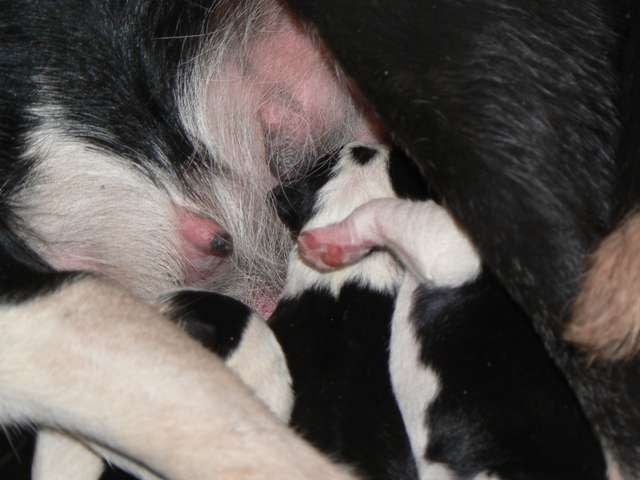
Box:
[289, 0, 640, 472]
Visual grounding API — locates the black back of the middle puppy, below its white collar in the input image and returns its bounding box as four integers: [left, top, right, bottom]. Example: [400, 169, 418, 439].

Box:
[269, 284, 417, 480]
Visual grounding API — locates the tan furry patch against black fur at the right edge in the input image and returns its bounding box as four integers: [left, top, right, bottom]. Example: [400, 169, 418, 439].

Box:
[565, 211, 640, 361]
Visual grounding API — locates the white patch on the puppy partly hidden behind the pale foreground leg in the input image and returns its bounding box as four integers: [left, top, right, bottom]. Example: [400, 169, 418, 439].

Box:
[226, 314, 293, 423]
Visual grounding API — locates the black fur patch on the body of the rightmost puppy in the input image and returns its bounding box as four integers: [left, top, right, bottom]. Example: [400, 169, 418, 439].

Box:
[411, 274, 606, 480]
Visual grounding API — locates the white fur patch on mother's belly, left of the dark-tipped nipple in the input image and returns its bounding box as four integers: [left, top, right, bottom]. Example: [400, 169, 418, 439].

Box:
[12, 118, 184, 300]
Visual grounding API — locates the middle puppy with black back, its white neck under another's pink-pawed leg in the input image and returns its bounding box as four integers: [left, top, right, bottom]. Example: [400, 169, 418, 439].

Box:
[269, 144, 417, 480]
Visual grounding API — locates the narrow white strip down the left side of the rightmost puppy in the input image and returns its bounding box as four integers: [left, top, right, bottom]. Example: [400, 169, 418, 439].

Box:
[389, 274, 444, 480]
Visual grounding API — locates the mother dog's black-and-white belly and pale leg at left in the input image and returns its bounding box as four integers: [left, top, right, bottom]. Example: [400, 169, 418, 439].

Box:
[0, 0, 372, 480]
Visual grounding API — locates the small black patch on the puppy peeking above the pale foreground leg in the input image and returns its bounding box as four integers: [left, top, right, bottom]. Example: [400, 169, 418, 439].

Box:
[169, 290, 251, 359]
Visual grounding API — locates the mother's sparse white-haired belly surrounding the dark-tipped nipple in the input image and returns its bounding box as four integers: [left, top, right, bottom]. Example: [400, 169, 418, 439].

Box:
[12, 0, 370, 316]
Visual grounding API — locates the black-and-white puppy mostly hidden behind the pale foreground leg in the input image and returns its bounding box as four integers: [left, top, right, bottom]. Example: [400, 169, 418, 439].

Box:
[33, 290, 293, 480]
